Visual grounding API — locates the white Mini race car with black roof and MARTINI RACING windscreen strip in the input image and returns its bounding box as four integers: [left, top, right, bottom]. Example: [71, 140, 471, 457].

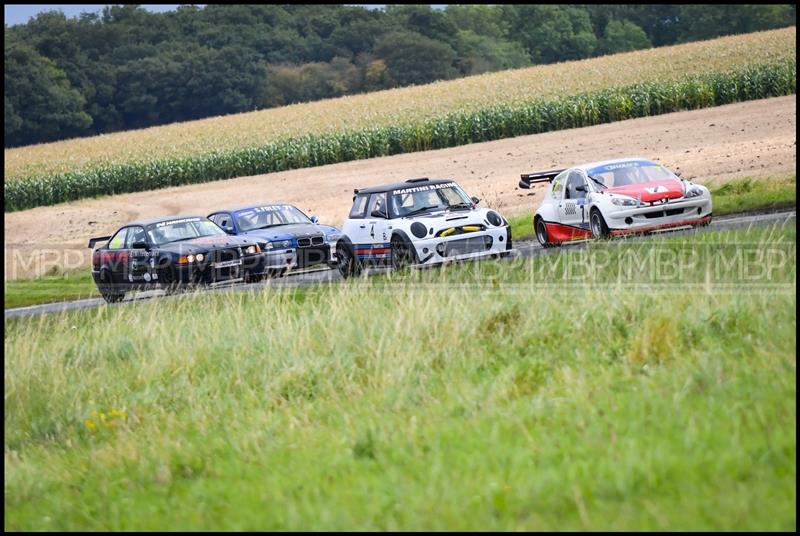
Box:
[336, 178, 512, 277]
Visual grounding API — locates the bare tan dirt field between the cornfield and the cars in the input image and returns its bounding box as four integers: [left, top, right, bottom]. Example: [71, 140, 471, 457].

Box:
[4, 96, 797, 279]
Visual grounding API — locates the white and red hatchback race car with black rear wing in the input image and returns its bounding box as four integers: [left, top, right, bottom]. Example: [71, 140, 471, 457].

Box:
[519, 158, 711, 246]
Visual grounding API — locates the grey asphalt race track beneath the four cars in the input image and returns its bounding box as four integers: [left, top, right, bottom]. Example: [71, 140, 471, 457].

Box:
[5, 210, 797, 319]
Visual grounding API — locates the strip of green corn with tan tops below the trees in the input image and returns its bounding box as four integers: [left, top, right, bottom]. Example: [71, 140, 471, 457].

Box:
[4, 28, 797, 212]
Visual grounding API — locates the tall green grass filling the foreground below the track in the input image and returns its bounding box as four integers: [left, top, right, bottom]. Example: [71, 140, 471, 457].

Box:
[4, 225, 796, 530]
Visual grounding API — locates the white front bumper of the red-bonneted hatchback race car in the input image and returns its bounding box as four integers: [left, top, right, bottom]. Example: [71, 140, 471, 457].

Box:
[603, 197, 711, 234]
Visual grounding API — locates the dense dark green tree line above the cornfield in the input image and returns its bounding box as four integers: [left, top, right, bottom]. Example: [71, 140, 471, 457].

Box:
[4, 4, 796, 147]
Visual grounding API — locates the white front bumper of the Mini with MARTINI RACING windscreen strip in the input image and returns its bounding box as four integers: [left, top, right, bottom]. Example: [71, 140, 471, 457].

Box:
[414, 225, 511, 265]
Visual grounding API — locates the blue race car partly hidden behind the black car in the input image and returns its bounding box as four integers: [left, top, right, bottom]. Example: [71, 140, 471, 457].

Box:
[208, 203, 342, 268]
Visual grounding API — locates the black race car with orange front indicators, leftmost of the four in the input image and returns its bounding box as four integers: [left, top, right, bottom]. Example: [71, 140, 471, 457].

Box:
[89, 216, 276, 302]
